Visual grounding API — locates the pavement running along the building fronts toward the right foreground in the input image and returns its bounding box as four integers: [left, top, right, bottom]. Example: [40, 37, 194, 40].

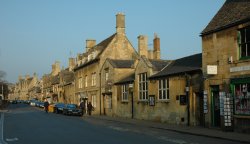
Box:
[88, 115, 250, 143]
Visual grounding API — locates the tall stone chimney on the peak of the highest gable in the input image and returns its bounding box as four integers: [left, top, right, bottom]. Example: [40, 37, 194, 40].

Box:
[116, 13, 125, 34]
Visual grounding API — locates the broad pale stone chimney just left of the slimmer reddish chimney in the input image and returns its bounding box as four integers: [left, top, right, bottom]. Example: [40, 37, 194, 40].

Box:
[138, 35, 148, 58]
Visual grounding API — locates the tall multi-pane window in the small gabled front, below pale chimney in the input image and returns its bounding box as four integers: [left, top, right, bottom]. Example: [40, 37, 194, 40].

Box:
[139, 73, 148, 100]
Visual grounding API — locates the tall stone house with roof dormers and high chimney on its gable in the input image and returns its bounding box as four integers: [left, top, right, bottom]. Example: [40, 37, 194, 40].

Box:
[74, 13, 137, 114]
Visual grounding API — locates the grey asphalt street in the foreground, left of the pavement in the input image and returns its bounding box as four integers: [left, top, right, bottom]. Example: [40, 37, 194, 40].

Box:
[0, 104, 245, 144]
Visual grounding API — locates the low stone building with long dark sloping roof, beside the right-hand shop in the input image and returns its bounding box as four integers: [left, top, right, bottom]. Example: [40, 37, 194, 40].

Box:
[147, 54, 203, 125]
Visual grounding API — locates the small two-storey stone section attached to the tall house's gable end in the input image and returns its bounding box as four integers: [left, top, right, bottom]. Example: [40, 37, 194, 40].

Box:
[100, 58, 135, 117]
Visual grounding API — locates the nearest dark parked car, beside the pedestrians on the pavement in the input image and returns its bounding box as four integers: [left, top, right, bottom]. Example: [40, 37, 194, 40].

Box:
[63, 104, 83, 116]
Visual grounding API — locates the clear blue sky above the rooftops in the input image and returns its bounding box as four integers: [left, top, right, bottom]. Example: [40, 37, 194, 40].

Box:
[0, 0, 225, 83]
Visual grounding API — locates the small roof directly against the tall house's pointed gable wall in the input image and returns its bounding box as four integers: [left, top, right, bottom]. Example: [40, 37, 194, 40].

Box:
[108, 59, 134, 68]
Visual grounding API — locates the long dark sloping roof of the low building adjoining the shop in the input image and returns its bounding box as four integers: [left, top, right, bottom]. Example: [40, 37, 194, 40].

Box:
[150, 53, 202, 79]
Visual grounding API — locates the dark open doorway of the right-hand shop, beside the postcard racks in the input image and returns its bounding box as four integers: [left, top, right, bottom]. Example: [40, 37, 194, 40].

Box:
[211, 85, 220, 127]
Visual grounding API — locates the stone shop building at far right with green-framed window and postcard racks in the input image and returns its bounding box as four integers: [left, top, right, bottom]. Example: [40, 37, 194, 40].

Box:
[201, 0, 250, 132]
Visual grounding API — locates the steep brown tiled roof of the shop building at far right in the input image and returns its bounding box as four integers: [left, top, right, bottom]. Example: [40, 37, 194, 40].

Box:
[201, 0, 250, 35]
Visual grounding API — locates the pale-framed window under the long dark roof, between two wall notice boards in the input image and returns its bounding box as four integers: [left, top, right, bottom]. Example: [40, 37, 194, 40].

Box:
[158, 79, 169, 100]
